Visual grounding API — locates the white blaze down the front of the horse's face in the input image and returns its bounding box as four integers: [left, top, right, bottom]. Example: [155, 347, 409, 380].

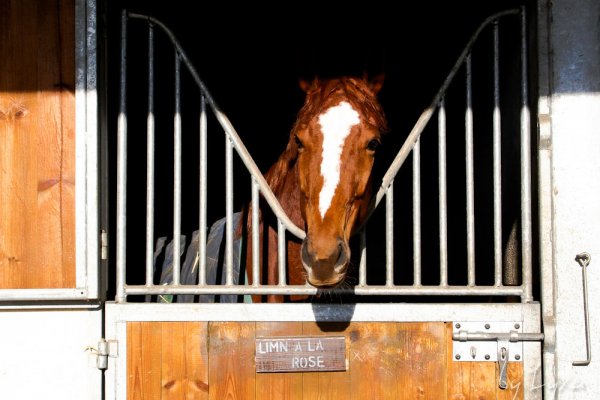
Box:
[319, 101, 360, 218]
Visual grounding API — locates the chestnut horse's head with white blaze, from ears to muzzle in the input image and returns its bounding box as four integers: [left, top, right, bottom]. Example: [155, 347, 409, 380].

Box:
[290, 77, 387, 287]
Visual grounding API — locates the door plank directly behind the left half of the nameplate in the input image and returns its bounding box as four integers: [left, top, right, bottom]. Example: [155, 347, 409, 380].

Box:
[256, 322, 302, 400]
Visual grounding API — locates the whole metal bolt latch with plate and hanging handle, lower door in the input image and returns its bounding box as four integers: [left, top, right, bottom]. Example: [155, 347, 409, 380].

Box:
[452, 321, 544, 389]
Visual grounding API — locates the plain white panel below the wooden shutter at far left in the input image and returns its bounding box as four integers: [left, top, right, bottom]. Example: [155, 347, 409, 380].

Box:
[0, 309, 102, 400]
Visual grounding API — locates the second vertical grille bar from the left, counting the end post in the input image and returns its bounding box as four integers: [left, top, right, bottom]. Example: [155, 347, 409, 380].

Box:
[146, 23, 154, 286]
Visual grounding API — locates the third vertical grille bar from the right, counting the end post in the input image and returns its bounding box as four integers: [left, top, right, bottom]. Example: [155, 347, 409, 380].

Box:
[465, 54, 475, 286]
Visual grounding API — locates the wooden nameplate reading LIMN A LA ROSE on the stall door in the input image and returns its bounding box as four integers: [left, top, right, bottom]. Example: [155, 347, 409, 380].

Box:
[255, 336, 347, 372]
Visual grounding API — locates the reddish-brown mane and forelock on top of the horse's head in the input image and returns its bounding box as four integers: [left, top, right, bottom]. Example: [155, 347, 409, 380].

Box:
[265, 77, 388, 194]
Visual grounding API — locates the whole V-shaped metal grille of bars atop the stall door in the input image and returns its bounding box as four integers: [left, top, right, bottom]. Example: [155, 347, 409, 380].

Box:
[116, 9, 532, 302]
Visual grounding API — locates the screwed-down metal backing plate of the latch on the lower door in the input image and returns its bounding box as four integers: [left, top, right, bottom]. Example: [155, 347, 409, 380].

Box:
[452, 321, 523, 362]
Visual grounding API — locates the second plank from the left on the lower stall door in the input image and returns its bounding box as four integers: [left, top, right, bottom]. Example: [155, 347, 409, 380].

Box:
[160, 322, 208, 400]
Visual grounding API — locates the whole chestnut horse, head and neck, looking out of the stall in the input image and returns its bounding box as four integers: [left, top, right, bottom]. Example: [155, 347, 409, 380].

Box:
[238, 75, 388, 302]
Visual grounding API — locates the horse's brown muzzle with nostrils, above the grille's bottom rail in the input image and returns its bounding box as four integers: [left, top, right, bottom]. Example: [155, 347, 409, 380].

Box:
[300, 239, 350, 288]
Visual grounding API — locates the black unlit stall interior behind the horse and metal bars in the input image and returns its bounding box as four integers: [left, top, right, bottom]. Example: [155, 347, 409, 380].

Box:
[103, 0, 535, 301]
